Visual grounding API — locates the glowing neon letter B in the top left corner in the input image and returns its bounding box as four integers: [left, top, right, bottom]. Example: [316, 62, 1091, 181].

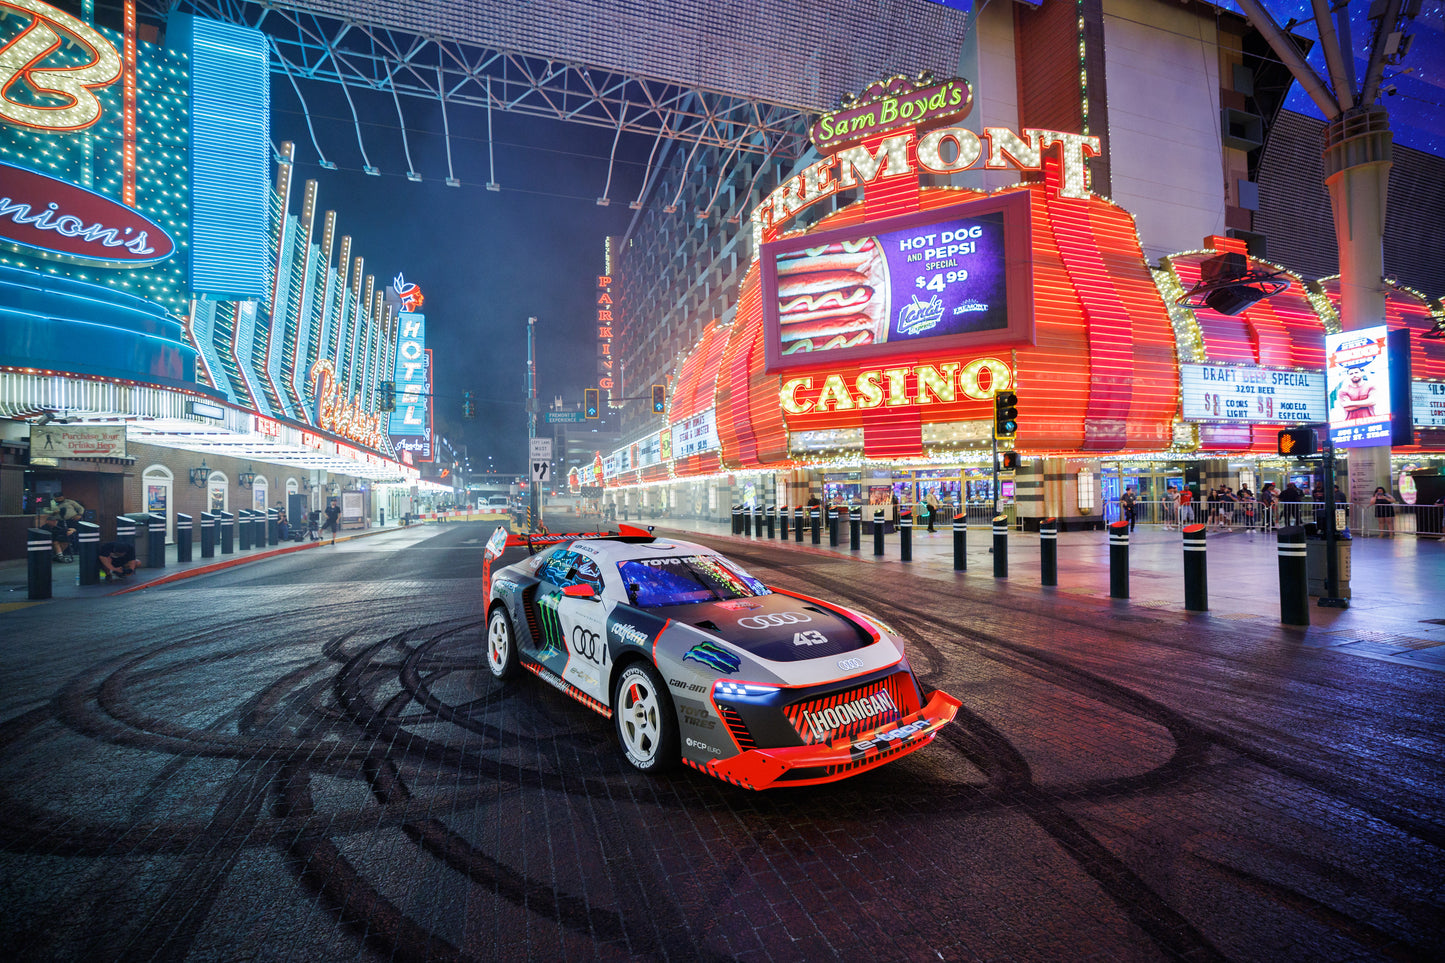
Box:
[0, 0, 121, 132]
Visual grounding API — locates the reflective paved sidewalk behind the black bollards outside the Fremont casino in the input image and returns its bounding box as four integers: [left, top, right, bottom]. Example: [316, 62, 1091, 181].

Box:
[644, 518, 1445, 671]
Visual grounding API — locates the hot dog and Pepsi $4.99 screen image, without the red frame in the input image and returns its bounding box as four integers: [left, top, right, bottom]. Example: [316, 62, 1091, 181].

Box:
[773, 213, 1009, 357]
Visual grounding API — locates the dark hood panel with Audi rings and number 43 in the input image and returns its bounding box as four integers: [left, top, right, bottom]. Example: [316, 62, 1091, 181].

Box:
[649, 594, 874, 662]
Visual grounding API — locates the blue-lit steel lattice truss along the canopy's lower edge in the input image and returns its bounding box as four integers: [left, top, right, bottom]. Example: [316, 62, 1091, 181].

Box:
[161, 0, 811, 161]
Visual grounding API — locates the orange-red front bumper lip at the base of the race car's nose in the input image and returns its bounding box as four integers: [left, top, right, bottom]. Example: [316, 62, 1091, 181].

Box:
[689, 691, 962, 789]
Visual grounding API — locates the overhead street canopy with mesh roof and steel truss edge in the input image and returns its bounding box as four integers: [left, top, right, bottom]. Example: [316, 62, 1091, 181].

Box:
[150, 0, 968, 161]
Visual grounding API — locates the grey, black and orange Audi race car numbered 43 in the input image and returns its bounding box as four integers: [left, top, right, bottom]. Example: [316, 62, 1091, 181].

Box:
[483, 525, 959, 789]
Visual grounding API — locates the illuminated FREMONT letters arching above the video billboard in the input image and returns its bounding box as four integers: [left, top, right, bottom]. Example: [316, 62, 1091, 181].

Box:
[753, 127, 1100, 250]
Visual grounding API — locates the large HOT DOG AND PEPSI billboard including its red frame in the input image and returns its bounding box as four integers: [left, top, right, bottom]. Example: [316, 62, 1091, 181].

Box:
[760, 191, 1033, 370]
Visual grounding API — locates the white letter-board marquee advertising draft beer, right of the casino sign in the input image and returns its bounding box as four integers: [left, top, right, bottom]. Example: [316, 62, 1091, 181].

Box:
[1179, 364, 1328, 425]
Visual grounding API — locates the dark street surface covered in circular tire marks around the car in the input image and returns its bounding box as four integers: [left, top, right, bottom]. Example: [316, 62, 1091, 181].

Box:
[0, 523, 1445, 962]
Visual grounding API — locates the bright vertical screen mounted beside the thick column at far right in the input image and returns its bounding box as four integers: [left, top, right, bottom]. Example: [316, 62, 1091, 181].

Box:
[1325, 324, 1390, 448]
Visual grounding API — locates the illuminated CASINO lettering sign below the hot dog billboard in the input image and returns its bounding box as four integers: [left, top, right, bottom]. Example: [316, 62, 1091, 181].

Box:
[777, 357, 1013, 415]
